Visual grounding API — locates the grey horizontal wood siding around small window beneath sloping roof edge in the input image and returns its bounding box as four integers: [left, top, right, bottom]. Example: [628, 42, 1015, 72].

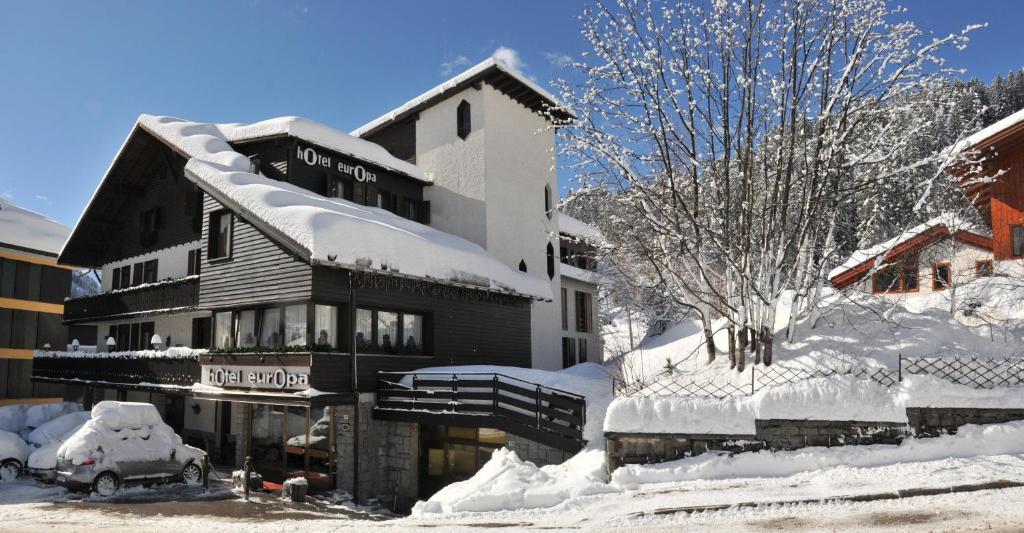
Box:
[199, 194, 312, 309]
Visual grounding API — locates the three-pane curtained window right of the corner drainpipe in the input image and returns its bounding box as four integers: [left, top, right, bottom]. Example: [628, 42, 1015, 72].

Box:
[355, 309, 426, 354]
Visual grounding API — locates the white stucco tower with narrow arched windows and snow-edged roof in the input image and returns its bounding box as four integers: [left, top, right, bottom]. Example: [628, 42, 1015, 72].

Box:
[353, 59, 577, 369]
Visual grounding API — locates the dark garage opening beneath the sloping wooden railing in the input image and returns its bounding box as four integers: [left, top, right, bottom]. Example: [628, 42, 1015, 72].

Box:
[419, 426, 508, 499]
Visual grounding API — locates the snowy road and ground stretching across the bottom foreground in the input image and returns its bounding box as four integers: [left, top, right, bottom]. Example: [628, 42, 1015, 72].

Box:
[0, 454, 1024, 533]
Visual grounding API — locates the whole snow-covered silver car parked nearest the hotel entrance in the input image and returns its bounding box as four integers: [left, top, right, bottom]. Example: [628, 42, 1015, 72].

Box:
[55, 401, 206, 496]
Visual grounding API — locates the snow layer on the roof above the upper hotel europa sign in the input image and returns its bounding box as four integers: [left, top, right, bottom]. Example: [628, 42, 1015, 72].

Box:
[226, 117, 427, 181]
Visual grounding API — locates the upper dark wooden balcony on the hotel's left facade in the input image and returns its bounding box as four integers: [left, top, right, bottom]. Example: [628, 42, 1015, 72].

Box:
[63, 276, 199, 324]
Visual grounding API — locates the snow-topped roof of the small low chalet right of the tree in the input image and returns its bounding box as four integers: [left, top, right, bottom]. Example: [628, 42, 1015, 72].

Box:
[828, 213, 992, 286]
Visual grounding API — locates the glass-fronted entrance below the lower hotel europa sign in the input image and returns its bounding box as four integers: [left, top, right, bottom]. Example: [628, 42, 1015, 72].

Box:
[246, 404, 335, 490]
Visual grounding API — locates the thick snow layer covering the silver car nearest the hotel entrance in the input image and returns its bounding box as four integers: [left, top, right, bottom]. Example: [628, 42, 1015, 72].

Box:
[57, 401, 203, 464]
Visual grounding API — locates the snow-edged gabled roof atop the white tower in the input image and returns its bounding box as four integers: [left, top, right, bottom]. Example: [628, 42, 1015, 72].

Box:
[352, 57, 575, 137]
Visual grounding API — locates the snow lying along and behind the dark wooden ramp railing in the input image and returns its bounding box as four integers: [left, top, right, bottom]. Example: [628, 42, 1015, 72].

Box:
[401, 363, 612, 439]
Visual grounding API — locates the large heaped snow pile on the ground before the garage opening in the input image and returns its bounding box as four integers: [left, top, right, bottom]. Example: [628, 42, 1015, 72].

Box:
[413, 448, 615, 517]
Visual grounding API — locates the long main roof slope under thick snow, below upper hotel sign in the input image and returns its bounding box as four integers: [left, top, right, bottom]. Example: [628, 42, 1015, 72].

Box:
[138, 115, 552, 299]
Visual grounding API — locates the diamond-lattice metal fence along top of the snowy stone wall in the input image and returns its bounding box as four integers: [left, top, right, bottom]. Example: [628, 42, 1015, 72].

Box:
[614, 356, 1024, 399]
